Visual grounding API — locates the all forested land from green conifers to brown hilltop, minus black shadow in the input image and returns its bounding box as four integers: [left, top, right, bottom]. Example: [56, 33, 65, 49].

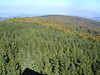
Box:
[0, 15, 100, 75]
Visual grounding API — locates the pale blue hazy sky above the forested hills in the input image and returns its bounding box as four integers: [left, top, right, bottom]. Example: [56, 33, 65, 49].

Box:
[0, 0, 100, 17]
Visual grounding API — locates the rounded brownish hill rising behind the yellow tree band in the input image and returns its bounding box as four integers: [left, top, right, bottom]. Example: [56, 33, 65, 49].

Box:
[43, 15, 100, 35]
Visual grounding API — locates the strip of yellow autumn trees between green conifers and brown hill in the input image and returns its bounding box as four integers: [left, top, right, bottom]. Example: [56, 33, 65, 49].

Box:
[0, 17, 100, 40]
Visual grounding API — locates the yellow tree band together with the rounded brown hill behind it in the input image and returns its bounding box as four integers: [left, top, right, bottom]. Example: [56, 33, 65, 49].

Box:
[1, 15, 100, 36]
